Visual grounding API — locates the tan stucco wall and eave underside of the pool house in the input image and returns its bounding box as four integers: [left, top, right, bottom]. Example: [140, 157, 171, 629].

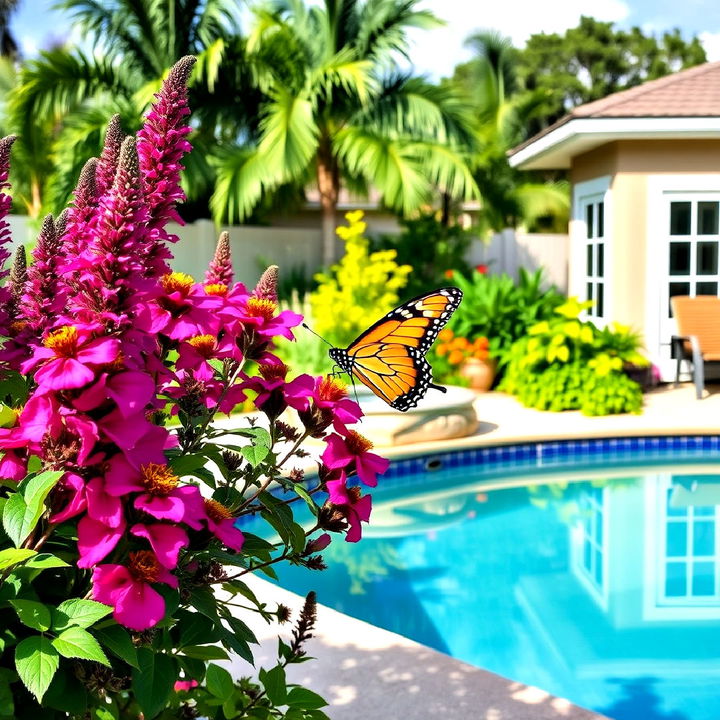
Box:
[570, 139, 720, 352]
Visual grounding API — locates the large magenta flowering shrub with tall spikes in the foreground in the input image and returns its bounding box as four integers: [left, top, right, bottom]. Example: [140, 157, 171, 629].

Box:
[0, 58, 388, 720]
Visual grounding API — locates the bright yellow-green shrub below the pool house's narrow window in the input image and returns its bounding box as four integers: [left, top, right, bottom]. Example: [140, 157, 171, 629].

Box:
[499, 298, 647, 415]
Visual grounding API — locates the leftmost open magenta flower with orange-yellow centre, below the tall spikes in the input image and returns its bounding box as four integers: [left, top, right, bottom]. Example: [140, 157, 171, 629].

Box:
[22, 325, 120, 391]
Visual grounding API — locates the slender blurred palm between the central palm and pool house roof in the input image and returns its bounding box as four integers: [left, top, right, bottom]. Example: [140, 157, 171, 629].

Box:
[454, 31, 570, 232]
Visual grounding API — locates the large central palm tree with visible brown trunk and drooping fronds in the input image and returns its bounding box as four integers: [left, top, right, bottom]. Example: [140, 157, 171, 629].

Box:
[211, 0, 477, 264]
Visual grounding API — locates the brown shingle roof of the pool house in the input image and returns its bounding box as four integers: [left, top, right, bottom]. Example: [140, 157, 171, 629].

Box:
[570, 62, 720, 117]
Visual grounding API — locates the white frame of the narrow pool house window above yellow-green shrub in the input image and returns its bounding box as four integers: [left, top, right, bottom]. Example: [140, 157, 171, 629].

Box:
[570, 175, 613, 327]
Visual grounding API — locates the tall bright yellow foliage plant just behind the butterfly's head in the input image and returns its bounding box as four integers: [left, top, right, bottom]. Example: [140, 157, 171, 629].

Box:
[310, 210, 412, 346]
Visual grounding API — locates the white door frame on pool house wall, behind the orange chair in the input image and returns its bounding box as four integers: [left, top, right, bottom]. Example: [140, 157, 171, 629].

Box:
[644, 173, 720, 380]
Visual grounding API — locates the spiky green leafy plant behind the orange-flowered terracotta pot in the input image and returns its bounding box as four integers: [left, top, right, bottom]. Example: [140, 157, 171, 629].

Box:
[450, 268, 565, 370]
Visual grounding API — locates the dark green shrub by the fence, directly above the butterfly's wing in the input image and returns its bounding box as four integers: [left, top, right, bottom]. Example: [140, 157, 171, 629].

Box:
[373, 213, 473, 298]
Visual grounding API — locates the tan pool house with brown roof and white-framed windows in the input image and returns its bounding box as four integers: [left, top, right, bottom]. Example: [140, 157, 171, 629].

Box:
[510, 62, 720, 380]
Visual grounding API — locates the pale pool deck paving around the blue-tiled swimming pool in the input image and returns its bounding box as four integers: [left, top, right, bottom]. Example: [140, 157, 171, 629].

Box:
[237, 383, 720, 720]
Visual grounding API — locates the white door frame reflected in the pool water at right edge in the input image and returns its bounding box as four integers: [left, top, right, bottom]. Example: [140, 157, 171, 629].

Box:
[642, 473, 720, 621]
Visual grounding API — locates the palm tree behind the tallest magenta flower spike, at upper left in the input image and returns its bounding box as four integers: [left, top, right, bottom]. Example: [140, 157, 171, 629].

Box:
[9, 0, 260, 214]
